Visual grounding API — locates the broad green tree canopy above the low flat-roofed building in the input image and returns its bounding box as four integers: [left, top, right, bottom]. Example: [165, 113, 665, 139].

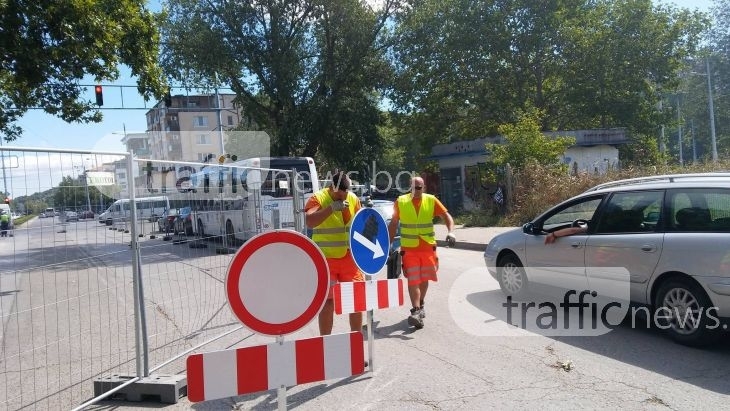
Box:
[391, 0, 708, 164]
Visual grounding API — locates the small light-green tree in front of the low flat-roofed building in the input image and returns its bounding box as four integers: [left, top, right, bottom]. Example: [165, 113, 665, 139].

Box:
[486, 110, 575, 170]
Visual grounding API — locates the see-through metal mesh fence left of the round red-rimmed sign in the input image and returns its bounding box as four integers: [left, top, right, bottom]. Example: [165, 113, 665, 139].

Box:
[0, 147, 312, 409]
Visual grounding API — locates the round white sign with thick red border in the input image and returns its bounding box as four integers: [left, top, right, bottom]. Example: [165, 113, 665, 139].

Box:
[225, 230, 329, 336]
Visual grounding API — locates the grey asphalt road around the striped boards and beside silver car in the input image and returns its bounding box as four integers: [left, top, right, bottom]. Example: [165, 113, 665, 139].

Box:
[77, 249, 730, 410]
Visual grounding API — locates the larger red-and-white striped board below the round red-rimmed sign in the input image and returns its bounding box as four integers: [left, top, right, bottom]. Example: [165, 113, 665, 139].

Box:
[187, 331, 365, 402]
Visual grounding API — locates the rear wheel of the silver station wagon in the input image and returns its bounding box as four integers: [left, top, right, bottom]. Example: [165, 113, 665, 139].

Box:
[654, 279, 720, 347]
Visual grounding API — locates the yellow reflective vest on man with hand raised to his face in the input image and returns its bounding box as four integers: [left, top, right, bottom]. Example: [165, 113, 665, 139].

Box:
[312, 188, 358, 258]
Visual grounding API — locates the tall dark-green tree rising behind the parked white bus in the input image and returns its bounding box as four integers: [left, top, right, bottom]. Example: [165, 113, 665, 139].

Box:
[163, 0, 402, 168]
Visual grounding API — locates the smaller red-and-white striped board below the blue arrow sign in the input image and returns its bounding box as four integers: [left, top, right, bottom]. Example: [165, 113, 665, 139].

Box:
[332, 278, 404, 314]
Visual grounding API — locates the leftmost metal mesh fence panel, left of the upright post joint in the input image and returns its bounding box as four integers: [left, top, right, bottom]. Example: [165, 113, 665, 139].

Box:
[0, 150, 135, 409]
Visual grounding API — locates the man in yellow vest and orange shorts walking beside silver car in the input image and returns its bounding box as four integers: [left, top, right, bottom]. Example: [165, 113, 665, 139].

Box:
[388, 177, 456, 329]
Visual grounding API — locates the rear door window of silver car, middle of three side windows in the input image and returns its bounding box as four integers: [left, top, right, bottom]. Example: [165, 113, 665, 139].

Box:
[595, 191, 664, 234]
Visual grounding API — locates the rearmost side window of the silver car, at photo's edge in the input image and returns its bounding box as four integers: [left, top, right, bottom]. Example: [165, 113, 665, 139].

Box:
[669, 189, 730, 232]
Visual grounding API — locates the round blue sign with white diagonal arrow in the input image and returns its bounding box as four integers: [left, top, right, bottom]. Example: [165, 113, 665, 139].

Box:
[350, 208, 390, 275]
